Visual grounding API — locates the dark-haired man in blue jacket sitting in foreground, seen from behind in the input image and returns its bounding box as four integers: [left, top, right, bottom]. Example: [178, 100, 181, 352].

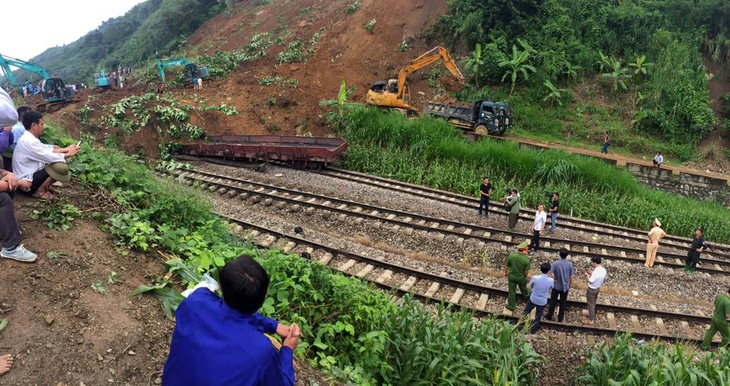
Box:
[162, 255, 301, 386]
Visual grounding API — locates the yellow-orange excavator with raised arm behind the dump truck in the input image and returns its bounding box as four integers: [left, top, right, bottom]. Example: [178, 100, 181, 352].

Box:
[366, 46, 464, 112]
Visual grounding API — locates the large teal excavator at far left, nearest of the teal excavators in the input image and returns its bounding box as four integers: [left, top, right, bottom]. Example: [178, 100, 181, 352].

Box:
[0, 54, 78, 113]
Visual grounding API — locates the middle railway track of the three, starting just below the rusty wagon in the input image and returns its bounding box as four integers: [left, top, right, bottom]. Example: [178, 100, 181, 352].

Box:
[172, 169, 730, 275]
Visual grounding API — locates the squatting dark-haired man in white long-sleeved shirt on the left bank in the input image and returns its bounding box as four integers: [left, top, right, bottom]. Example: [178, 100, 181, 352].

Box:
[13, 111, 80, 200]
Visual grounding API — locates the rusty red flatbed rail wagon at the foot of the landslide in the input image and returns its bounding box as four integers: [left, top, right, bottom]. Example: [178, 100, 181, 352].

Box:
[179, 135, 347, 168]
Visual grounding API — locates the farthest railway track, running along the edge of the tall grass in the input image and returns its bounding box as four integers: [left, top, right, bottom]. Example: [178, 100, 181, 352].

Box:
[318, 168, 730, 255]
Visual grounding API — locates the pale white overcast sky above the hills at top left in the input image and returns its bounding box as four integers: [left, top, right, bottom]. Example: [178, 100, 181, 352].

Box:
[0, 0, 144, 60]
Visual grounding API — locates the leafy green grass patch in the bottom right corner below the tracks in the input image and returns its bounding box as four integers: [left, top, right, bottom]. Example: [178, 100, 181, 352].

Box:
[576, 335, 730, 386]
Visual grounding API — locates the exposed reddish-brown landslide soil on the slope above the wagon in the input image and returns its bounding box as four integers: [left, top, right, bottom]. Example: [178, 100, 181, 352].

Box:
[182, 0, 450, 135]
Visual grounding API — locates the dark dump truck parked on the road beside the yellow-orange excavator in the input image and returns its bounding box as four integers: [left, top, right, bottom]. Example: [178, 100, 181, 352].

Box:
[423, 100, 514, 135]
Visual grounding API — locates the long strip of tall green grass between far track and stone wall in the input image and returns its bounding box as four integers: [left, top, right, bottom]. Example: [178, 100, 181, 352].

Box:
[341, 108, 730, 243]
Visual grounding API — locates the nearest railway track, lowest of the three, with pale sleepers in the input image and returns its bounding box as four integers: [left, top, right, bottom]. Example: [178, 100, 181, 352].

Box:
[213, 213, 717, 344]
